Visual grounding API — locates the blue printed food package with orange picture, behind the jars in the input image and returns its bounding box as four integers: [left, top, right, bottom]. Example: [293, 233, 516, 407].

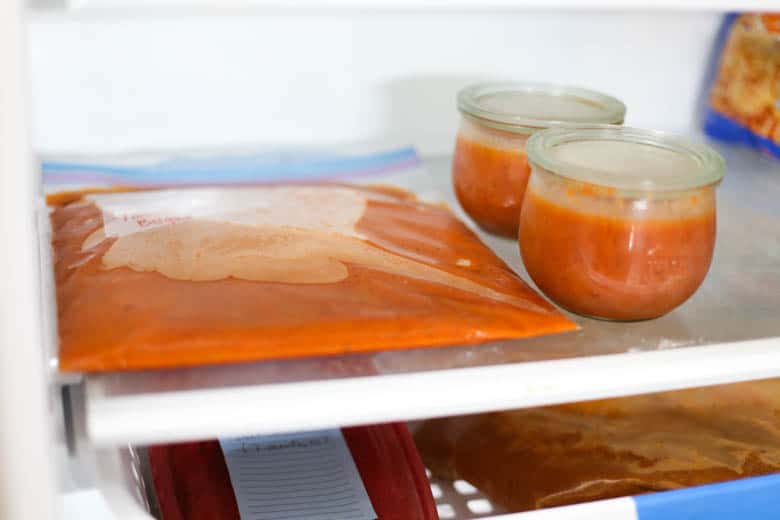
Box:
[704, 13, 780, 158]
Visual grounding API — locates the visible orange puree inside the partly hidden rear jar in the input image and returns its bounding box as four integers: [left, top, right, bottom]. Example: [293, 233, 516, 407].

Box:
[452, 136, 531, 237]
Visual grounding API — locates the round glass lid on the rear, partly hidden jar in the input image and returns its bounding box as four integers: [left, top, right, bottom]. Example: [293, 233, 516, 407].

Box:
[458, 82, 626, 134]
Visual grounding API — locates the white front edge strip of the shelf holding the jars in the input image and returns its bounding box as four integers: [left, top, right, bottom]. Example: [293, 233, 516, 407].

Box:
[86, 337, 780, 447]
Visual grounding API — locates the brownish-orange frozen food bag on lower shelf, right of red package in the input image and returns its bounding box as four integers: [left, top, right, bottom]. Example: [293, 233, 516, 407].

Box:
[415, 380, 780, 511]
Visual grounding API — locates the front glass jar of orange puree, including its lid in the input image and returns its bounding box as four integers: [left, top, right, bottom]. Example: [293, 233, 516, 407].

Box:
[519, 125, 725, 321]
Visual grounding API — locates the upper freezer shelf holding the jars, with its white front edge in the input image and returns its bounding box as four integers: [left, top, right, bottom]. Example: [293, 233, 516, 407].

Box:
[77, 139, 780, 446]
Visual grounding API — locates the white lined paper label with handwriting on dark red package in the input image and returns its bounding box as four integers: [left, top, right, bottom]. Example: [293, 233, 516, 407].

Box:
[219, 429, 376, 520]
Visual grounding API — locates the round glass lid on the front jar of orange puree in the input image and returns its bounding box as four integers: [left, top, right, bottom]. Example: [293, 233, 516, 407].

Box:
[526, 125, 726, 191]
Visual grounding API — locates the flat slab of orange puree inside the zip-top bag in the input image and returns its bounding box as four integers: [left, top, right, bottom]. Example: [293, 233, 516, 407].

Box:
[51, 186, 576, 371]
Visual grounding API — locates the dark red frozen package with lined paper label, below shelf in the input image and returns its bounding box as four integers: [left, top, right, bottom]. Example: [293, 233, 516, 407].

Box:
[148, 424, 438, 520]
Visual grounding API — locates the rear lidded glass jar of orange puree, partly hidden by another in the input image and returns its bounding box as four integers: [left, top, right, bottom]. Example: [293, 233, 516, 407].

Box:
[452, 83, 626, 237]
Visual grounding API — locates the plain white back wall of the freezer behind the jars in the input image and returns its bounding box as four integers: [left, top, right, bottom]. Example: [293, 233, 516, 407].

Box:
[30, 9, 721, 154]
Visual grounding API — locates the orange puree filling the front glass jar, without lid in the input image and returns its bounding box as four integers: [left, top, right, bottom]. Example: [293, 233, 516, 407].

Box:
[519, 191, 715, 320]
